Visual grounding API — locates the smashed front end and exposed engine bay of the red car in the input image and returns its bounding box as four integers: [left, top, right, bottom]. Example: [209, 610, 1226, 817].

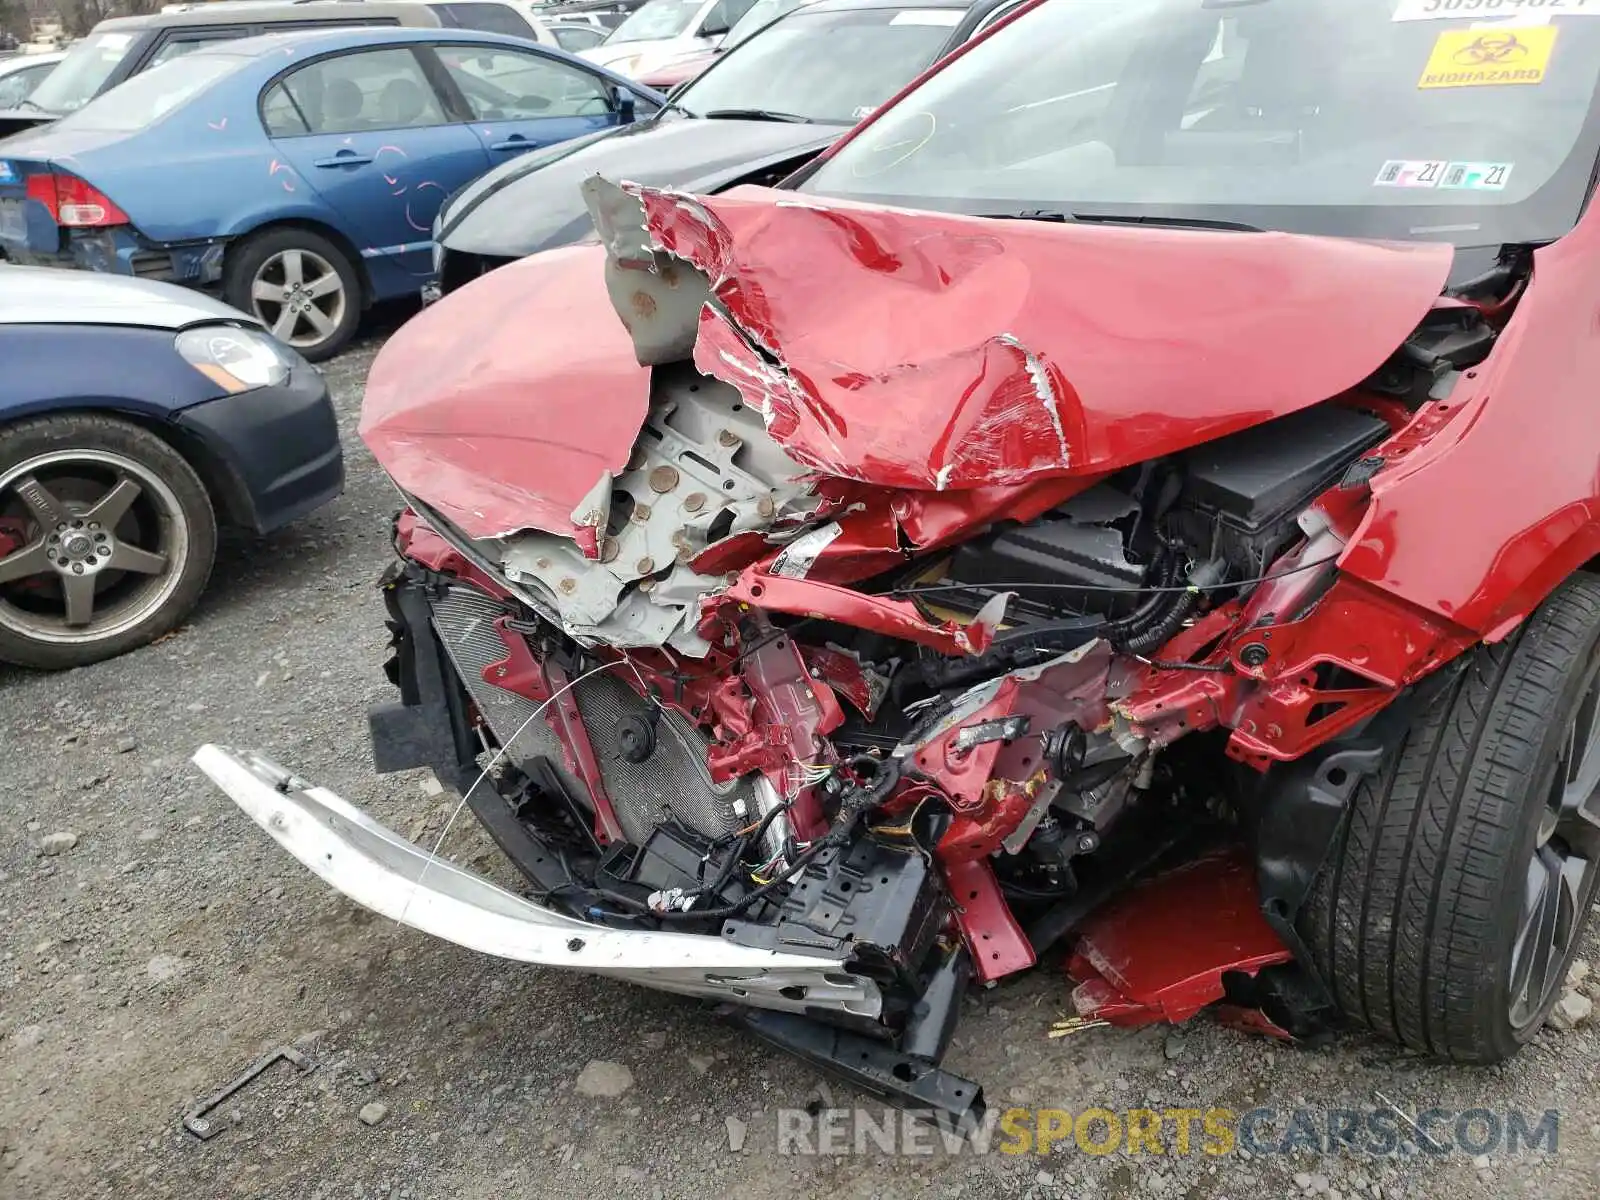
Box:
[193, 176, 1555, 1112]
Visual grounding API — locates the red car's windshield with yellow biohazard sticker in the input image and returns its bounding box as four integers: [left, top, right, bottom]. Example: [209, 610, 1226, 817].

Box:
[800, 0, 1600, 246]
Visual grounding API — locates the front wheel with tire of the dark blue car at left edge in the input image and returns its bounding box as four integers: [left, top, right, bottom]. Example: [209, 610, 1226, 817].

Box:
[0, 413, 216, 670]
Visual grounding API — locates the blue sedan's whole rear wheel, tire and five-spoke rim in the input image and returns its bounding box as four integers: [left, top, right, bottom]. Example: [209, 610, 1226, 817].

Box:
[222, 226, 362, 363]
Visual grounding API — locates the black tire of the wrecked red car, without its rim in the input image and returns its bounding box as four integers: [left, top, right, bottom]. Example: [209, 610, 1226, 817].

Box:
[1299, 574, 1600, 1064]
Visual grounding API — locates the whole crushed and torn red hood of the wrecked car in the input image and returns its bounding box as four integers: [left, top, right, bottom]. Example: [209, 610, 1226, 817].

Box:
[362, 179, 1453, 536]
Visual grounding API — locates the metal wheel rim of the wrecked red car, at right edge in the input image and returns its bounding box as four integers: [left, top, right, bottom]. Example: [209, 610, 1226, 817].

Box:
[1510, 662, 1600, 1030]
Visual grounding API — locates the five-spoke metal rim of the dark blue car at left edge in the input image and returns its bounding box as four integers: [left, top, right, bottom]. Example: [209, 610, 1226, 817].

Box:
[0, 450, 189, 645]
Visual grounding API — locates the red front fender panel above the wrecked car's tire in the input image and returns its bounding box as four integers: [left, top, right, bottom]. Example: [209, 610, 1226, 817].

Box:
[1341, 205, 1600, 638]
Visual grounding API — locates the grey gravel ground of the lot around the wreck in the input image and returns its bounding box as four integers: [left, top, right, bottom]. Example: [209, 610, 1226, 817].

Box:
[0, 331, 1600, 1200]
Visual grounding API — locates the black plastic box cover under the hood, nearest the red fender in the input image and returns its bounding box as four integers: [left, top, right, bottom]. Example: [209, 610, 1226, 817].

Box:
[1182, 403, 1389, 533]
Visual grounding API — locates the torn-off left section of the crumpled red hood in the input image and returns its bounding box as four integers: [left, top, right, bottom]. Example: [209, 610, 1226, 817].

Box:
[360, 245, 650, 538]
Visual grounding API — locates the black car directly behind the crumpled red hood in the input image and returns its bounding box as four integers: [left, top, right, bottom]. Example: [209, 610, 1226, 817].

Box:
[427, 0, 1021, 298]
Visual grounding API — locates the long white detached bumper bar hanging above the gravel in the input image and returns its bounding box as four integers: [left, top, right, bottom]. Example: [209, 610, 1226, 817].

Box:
[194, 746, 883, 1019]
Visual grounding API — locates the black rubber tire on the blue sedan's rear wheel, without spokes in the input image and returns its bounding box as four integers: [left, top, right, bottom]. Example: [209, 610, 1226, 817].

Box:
[222, 226, 366, 363]
